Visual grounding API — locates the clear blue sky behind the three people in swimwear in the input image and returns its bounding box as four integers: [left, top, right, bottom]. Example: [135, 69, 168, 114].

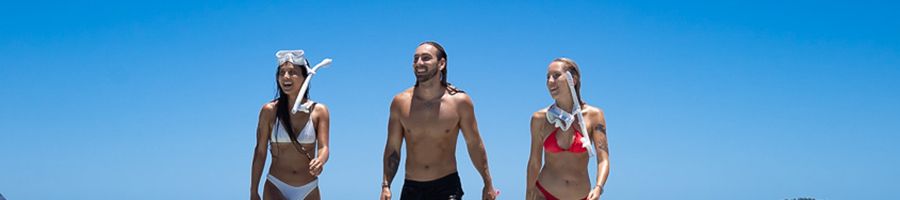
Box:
[0, 1, 900, 200]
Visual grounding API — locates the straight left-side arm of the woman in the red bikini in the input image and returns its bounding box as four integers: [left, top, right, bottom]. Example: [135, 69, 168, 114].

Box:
[525, 111, 546, 200]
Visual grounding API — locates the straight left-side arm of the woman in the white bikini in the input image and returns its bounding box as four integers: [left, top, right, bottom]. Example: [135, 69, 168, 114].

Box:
[250, 103, 275, 199]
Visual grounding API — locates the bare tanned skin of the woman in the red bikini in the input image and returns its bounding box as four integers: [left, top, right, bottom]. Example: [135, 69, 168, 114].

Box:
[525, 62, 609, 200]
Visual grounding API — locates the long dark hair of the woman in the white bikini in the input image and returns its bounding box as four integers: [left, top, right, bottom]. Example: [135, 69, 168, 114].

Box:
[273, 61, 312, 153]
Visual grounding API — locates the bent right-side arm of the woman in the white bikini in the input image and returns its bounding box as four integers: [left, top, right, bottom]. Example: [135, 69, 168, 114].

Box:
[309, 104, 331, 176]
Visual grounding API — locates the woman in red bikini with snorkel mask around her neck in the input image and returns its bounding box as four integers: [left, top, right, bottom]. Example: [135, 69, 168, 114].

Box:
[525, 58, 609, 200]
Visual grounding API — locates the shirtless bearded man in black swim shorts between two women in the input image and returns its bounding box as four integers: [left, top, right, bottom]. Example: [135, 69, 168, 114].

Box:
[381, 42, 497, 200]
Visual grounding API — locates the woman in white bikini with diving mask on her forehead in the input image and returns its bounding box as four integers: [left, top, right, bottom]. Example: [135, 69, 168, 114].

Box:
[250, 50, 329, 200]
